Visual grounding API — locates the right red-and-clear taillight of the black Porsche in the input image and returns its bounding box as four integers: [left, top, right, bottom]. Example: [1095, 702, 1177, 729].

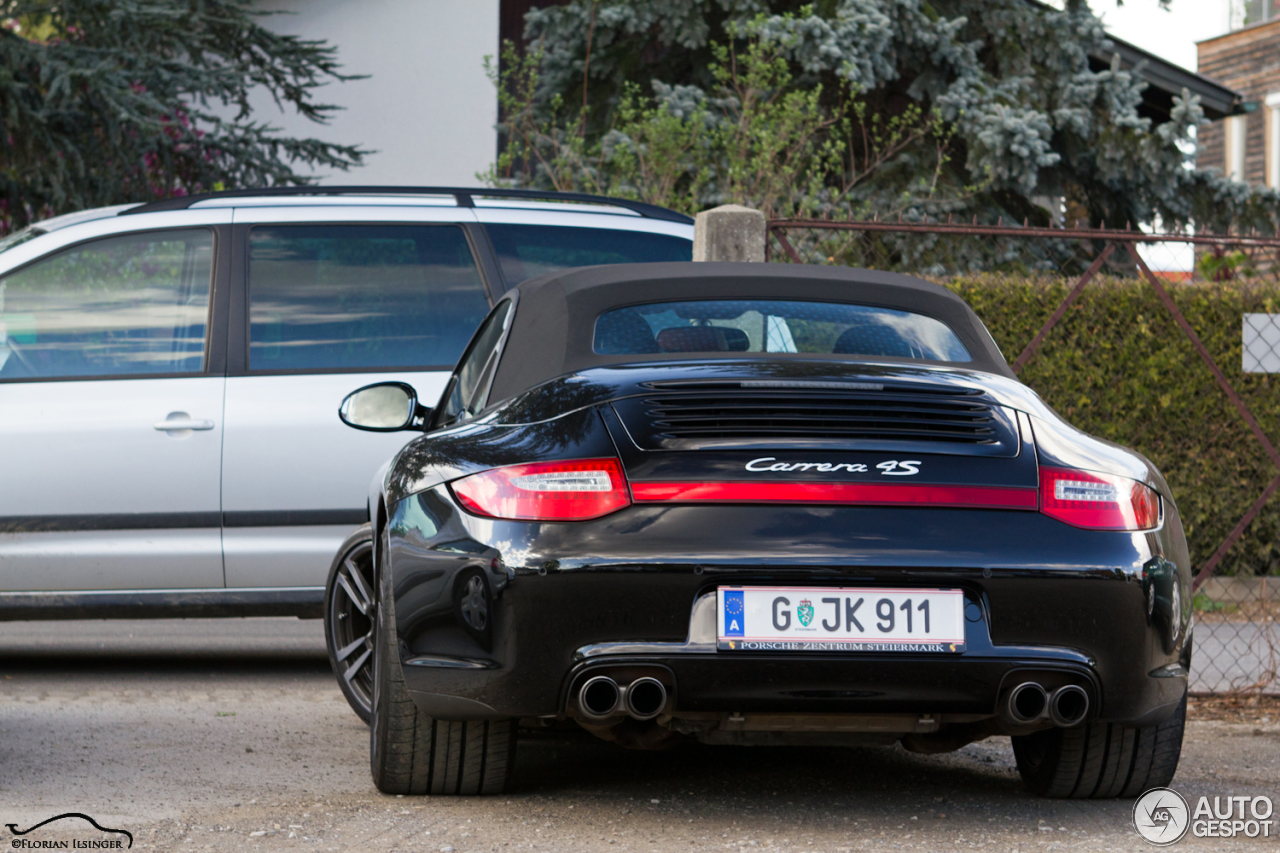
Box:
[1041, 467, 1160, 530]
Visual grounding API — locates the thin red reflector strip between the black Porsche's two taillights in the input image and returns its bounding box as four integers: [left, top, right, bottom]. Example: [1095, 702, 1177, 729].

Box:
[631, 482, 1037, 510]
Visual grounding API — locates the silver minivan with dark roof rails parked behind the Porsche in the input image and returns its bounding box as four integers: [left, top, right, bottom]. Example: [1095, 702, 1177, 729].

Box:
[0, 187, 694, 620]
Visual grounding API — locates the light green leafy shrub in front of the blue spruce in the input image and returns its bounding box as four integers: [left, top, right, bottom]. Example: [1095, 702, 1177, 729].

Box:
[477, 15, 956, 216]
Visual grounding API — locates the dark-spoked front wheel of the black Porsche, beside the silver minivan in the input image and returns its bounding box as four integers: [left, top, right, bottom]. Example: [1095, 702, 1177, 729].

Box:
[324, 524, 376, 724]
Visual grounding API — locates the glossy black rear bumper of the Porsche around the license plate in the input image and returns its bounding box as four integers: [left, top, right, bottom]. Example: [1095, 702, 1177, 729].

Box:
[384, 489, 1189, 724]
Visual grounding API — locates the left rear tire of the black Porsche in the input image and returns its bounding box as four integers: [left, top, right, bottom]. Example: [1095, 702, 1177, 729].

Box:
[369, 527, 516, 795]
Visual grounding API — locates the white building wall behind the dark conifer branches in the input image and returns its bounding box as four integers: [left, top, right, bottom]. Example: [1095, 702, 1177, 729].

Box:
[253, 0, 499, 186]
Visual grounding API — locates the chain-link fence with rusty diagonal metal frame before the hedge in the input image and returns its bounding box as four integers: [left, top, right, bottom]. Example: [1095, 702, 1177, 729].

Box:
[767, 220, 1280, 693]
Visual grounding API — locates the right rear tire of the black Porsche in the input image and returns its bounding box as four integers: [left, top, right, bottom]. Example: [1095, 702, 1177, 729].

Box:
[1012, 693, 1187, 799]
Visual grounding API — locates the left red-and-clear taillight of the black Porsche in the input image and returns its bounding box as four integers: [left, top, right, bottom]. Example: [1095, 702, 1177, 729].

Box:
[451, 459, 631, 521]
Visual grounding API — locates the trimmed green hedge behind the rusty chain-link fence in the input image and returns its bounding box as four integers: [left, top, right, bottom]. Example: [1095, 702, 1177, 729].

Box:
[941, 274, 1280, 574]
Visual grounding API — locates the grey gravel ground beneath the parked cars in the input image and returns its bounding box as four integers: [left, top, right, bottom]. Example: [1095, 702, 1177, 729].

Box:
[0, 620, 1280, 853]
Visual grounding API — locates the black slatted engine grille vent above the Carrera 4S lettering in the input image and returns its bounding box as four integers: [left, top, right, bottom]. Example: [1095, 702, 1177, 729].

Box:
[644, 388, 1000, 444]
